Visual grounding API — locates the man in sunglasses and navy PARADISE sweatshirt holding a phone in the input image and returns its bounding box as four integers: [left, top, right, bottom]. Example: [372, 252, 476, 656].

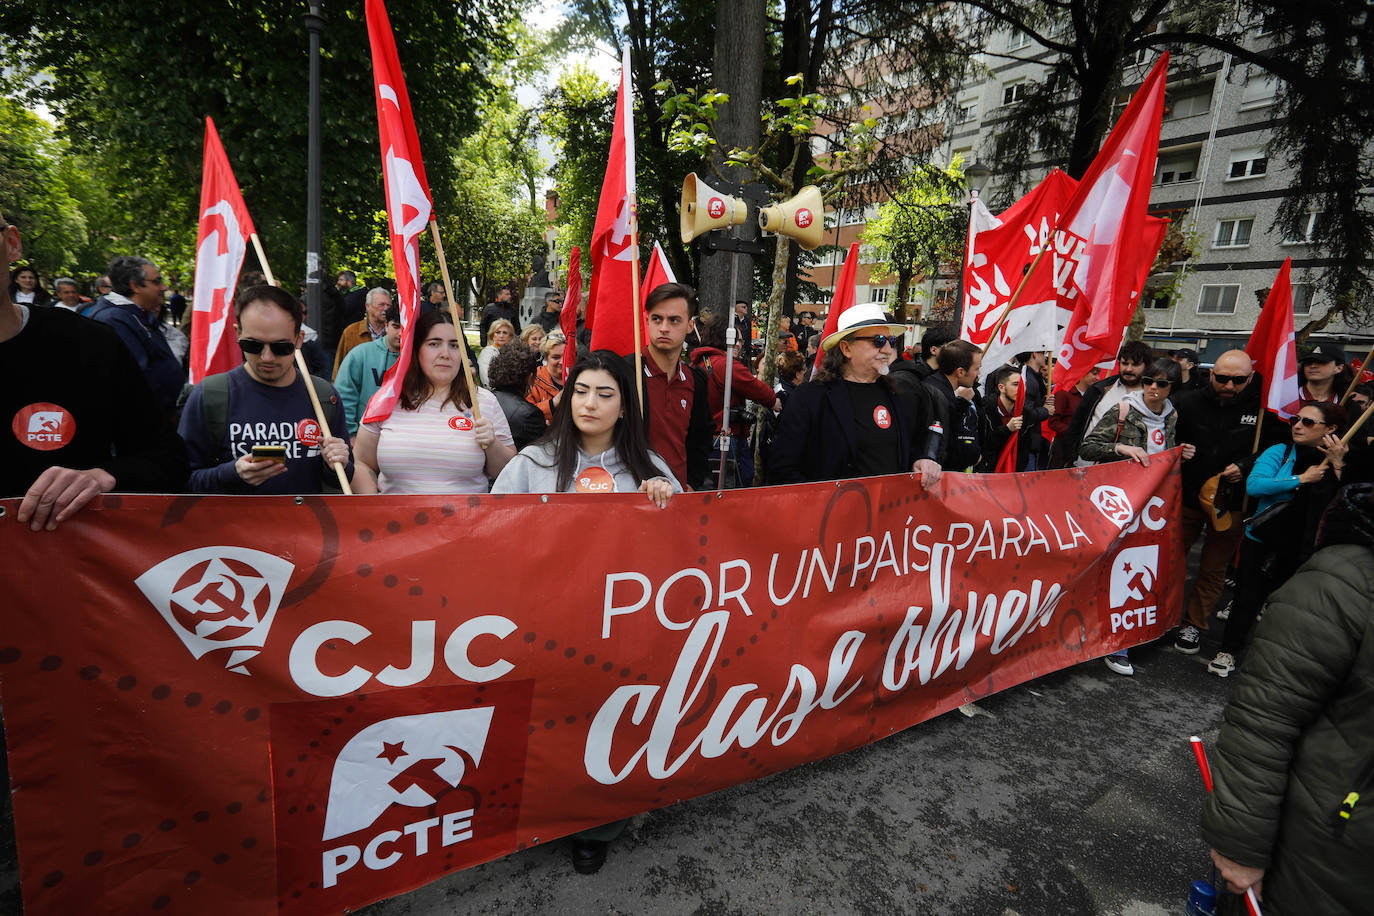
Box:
[177, 286, 353, 494]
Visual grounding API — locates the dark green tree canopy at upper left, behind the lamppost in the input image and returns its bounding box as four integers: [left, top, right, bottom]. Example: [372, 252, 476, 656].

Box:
[0, 0, 522, 282]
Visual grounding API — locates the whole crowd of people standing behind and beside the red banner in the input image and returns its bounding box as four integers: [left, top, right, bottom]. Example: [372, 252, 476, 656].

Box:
[0, 219, 1374, 895]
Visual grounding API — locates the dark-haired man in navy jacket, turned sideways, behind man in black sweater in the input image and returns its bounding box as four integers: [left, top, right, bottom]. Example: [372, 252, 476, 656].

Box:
[89, 255, 185, 423]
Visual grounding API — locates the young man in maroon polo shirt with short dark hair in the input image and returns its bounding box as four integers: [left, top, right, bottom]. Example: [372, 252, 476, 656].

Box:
[644, 283, 712, 490]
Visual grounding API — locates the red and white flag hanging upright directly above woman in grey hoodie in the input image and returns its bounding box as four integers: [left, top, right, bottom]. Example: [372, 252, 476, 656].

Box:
[585, 45, 646, 356]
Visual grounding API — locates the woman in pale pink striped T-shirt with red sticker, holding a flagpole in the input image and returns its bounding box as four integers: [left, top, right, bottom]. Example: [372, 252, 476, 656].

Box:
[353, 310, 515, 493]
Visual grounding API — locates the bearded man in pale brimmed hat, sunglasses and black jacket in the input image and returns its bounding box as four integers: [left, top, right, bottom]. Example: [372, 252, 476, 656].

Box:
[769, 302, 940, 488]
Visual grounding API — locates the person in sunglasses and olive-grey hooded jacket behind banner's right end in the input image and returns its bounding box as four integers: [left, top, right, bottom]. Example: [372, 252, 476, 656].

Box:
[1079, 360, 1195, 676]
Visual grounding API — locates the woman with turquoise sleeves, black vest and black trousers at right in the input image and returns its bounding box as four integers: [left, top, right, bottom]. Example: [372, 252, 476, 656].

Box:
[1208, 401, 1347, 677]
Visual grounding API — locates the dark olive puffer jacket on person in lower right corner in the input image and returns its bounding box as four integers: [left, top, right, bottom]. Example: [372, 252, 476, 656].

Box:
[1202, 485, 1374, 916]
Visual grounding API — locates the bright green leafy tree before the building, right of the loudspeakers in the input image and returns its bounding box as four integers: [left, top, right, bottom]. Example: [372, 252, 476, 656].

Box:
[863, 159, 969, 321]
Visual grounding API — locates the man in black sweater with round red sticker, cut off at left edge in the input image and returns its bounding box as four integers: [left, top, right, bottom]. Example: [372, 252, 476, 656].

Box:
[0, 216, 187, 531]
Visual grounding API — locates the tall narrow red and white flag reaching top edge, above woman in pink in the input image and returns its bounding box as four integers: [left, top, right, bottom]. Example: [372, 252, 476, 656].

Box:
[363, 0, 431, 423]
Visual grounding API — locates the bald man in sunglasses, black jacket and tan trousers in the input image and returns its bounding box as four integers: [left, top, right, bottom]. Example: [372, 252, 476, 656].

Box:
[1173, 350, 1286, 655]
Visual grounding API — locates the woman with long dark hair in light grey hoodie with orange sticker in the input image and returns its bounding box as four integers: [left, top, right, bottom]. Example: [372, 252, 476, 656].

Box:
[492, 350, 682, 508]
